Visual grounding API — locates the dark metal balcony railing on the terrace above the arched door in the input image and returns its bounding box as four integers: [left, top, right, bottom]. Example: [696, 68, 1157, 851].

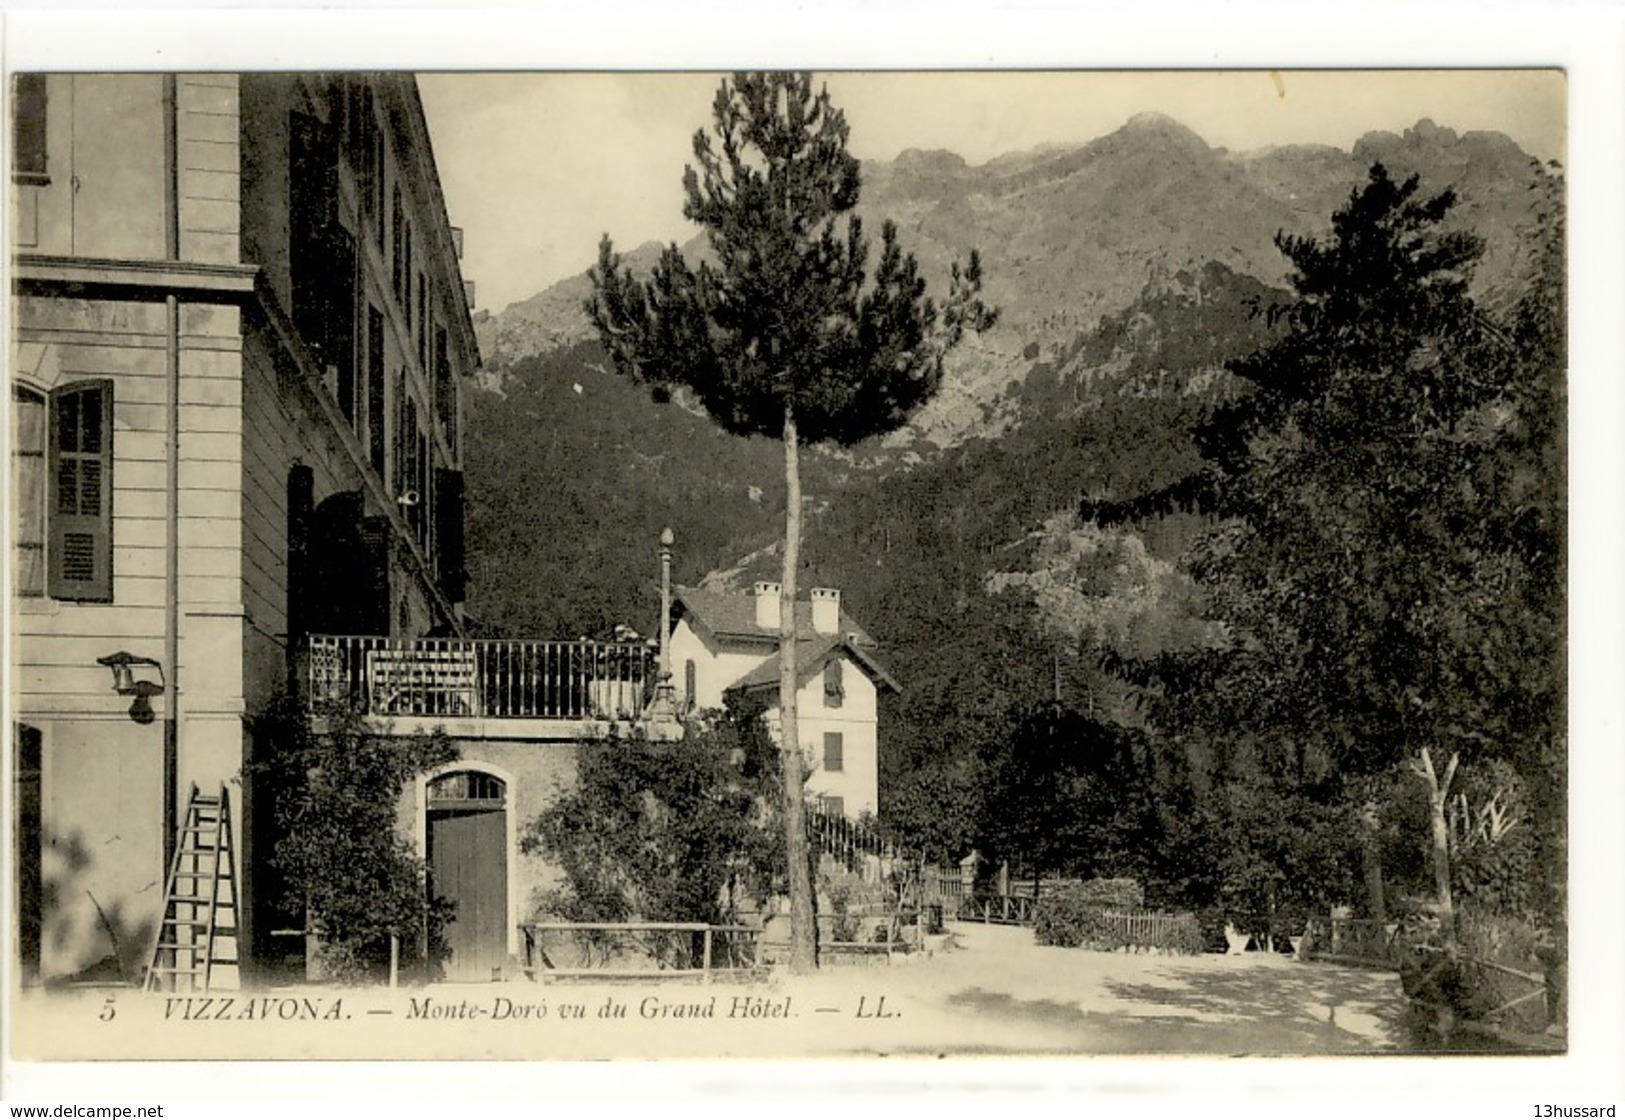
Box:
[307, 636, 657, 720]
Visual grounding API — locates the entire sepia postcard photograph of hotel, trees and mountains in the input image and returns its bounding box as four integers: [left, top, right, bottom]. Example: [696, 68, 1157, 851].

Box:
[5, 4, 1622, 1117]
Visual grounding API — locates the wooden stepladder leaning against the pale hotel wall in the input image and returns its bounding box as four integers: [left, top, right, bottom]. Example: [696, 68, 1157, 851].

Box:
[143, 785, 237, 993]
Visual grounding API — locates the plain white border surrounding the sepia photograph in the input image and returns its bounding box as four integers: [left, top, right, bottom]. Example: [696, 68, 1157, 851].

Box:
[0, 2, 1625, 1117]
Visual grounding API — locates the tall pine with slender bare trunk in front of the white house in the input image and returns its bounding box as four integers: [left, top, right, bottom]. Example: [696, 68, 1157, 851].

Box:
[587, 73, 995, 972]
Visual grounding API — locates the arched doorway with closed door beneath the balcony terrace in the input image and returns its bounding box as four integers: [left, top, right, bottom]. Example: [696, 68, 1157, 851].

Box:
[424, 771, 509, 980]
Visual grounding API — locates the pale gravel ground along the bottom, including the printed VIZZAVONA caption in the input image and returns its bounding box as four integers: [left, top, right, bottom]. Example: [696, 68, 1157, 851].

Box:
[13, 923, 1404, 1061]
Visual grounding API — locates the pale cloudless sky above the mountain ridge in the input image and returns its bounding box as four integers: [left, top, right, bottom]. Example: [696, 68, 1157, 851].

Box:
[419, 70, 1567, 310]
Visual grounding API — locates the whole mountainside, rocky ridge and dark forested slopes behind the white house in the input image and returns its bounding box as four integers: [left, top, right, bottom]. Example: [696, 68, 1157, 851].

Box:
[468, 117, 1550, 901]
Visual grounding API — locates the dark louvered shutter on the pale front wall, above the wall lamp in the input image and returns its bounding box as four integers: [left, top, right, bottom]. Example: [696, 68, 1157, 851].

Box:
[47, 380, 112, 603]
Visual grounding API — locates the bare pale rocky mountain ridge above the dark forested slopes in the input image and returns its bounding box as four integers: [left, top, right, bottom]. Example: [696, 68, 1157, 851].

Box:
[476, 112, 1531, 463]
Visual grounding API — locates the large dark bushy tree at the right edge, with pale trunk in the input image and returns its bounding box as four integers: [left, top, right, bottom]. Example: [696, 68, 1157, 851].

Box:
[1086, 164, 1562, 936]
